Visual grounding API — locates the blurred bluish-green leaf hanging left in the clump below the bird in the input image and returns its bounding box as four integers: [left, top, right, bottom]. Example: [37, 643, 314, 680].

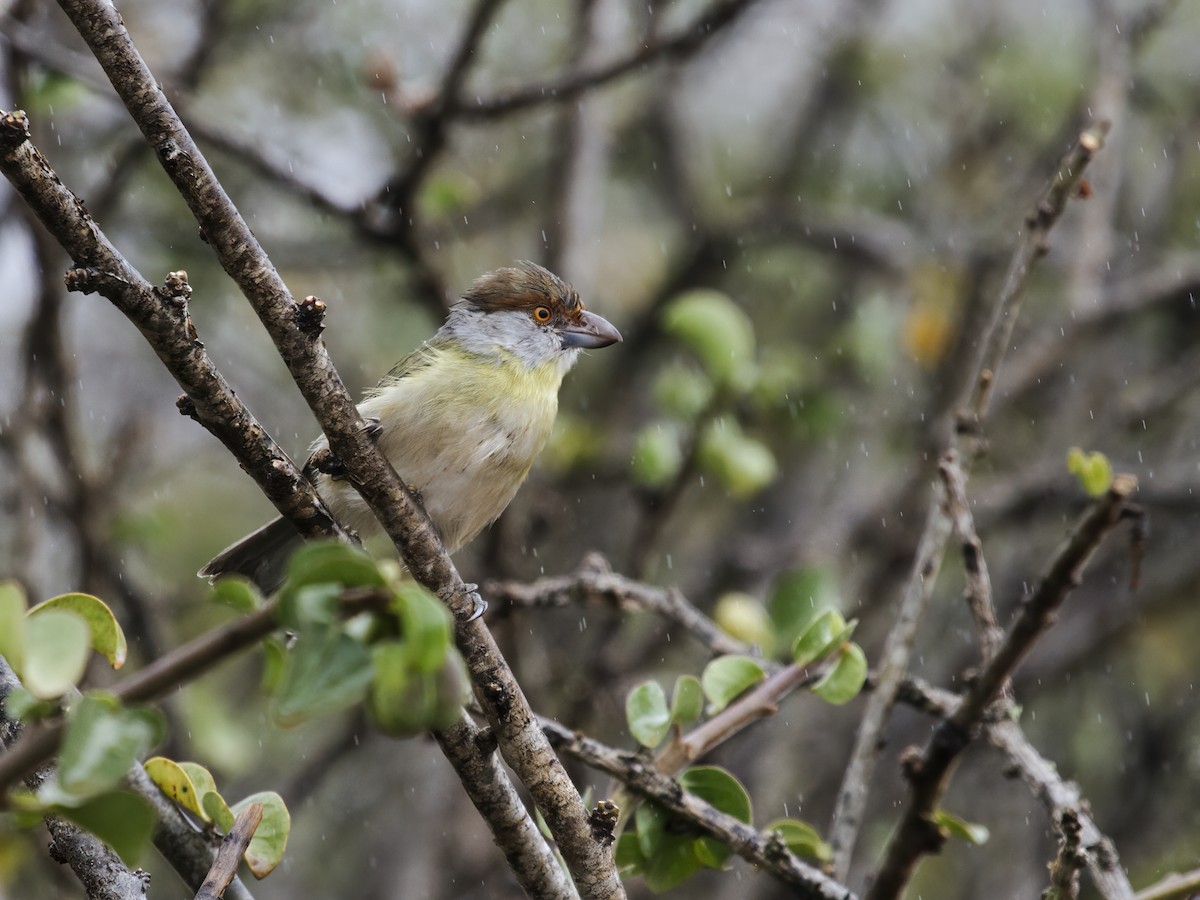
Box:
[275, 626, 374, 727]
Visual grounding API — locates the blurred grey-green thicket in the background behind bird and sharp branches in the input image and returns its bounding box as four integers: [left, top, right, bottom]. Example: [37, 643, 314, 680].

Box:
[0, 0, 1200, 899]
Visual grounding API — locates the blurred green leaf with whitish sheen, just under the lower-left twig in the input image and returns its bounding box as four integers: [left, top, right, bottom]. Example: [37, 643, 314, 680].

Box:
[57, 696, 166, 798]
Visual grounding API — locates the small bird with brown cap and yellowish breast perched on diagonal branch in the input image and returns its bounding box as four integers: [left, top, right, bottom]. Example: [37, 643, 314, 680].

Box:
[199, 262, 620, 592]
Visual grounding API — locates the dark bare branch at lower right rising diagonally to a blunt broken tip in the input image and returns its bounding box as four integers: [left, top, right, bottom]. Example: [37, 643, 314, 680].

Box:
[865, 475, 1140, 900]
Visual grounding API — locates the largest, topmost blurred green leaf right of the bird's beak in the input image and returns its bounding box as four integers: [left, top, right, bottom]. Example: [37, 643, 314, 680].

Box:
[662, 288, 755, 388]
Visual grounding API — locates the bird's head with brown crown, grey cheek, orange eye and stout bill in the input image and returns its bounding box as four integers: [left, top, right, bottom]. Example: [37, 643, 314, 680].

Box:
[439, 262, 620, 372]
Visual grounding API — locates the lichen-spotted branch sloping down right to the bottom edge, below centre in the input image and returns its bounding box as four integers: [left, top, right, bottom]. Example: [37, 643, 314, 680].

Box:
[541, 719, 854, 900]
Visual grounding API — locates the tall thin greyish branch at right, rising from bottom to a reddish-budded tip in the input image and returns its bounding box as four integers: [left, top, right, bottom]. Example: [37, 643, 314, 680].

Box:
[829, 122, 1108, 878]
